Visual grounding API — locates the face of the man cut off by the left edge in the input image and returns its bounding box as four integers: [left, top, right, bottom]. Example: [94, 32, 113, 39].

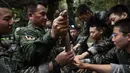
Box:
[0, 8, 13, 34]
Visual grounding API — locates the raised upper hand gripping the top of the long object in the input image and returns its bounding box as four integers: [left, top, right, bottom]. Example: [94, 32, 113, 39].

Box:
[51, 10, 69, 38]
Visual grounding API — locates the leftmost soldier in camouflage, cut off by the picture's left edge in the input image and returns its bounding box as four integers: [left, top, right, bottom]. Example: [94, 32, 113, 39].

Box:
[0, 5, 13, 73]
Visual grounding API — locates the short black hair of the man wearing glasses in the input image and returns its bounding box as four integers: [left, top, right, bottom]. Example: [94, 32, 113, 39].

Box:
[114, 18, 130, 35]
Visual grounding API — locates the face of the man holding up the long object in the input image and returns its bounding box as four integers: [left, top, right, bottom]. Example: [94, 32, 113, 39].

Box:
[32, 5, 47, 27]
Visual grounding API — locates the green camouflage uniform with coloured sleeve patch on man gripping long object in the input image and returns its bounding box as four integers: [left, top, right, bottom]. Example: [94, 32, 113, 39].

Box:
[12, 24, 56, 73]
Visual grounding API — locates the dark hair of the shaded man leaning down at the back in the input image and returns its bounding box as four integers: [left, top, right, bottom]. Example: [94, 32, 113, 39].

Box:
[76, 4, 92, 16]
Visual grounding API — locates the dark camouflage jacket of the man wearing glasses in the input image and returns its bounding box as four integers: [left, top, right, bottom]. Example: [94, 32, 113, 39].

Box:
[91, 48, 130, 73]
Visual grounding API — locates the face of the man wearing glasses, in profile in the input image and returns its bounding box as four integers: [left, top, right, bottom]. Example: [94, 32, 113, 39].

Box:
[112, 27, 129, 49]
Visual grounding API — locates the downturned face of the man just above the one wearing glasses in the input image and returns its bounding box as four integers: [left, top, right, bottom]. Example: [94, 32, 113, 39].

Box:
[109, 13, 124, 25]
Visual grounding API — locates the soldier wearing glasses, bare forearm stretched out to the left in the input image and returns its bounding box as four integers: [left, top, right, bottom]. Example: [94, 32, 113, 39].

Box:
[75, 19, 130, 73]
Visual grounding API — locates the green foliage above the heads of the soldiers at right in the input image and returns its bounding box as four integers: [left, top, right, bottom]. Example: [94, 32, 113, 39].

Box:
[74, 0, 118, 11]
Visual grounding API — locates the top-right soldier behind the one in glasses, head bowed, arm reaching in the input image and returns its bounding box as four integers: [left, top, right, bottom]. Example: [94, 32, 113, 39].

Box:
[74, 5, 130, 59]
